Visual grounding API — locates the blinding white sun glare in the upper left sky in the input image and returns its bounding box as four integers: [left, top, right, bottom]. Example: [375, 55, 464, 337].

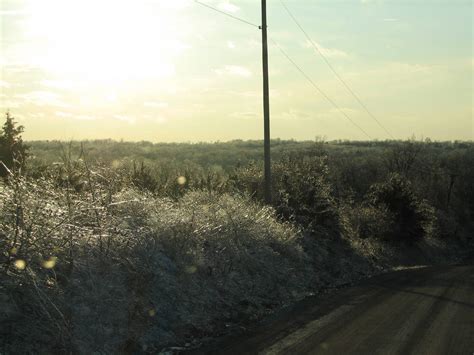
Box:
[25, 0, 190, 84]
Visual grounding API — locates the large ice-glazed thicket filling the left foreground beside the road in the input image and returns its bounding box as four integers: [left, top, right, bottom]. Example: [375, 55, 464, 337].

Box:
[0, 171, 310, 353]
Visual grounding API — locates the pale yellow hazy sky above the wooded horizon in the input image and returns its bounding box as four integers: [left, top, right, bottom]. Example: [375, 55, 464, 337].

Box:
[0, 0, 474, 142]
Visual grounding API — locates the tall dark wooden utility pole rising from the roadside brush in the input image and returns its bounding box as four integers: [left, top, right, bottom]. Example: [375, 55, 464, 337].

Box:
[260, 0, 272, 203]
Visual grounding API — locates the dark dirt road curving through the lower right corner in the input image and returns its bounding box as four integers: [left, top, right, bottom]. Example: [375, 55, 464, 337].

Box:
[195, 266, 474, 355]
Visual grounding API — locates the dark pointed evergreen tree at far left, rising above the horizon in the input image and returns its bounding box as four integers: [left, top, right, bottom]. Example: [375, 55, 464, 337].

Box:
[0, 112, 28, 177]
